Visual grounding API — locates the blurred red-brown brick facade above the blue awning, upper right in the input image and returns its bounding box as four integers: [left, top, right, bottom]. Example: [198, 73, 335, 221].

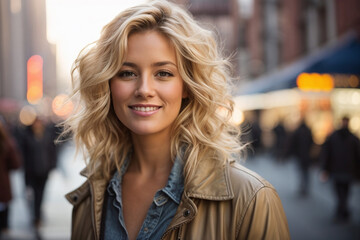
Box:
[239, 0, 360, 79]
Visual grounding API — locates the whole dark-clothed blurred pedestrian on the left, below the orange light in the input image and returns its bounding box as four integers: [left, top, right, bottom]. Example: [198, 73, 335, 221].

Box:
[23, 118, 57, 227]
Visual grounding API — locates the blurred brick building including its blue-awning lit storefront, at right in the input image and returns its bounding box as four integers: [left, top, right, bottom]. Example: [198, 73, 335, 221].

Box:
[235, 0, 360, 144]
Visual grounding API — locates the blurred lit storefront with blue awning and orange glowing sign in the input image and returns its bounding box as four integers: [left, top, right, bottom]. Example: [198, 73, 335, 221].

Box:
[234, 32, 360, 149]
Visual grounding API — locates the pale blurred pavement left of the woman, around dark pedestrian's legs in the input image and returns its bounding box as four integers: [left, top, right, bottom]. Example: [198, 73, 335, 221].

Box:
[3, 143, 85, 240]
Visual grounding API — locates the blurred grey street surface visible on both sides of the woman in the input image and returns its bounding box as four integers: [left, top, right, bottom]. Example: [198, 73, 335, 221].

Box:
[3, 144, 360, 240]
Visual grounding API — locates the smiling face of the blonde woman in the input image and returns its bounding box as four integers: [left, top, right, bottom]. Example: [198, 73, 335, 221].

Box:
[110, 30, 186, 135]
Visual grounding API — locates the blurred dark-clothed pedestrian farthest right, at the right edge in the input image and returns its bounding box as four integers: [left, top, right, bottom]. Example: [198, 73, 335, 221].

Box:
[320, 116, 360, 221]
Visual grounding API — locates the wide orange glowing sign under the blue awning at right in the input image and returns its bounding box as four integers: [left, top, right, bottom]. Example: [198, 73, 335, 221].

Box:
[296, 73, 334, 92]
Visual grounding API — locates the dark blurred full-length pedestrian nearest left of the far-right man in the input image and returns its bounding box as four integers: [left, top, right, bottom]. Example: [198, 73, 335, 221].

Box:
[287, 119, 314, 196]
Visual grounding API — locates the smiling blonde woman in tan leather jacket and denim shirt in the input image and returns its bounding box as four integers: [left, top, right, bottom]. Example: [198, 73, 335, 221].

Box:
[67, 1, 289, 239]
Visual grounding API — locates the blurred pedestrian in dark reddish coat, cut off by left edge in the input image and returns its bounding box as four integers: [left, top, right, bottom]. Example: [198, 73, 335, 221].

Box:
[0, 119, 21, 236]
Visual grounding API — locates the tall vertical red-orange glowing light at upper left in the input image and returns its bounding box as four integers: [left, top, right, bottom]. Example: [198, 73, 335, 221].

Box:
[26, 55, 43, 104]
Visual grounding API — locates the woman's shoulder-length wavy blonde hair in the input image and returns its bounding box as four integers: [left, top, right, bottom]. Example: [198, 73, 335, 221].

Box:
[65, 0, 242, 181]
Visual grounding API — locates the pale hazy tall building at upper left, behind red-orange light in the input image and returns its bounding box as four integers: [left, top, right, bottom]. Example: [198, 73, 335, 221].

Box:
[0, 0, 56, 103]
